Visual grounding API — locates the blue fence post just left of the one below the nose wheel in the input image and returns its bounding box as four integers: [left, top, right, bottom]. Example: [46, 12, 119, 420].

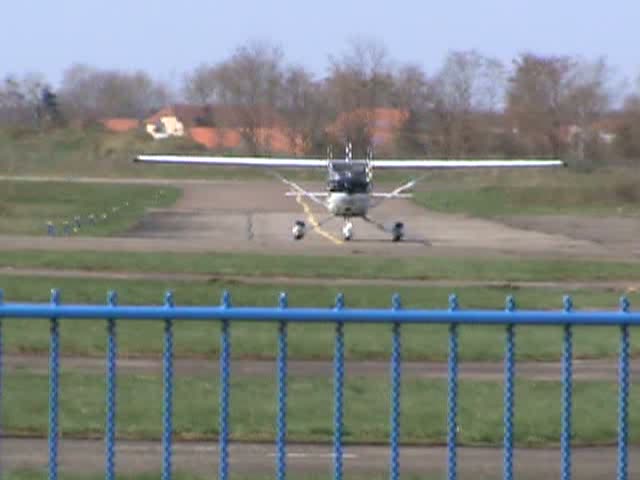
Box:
[276, 292, 288, 480]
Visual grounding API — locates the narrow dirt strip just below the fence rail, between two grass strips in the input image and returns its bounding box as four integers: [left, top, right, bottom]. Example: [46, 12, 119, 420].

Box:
[3, 354, 624, 382]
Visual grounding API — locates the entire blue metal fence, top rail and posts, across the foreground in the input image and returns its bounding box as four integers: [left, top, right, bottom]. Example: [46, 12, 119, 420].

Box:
[0, 290, 640, 480]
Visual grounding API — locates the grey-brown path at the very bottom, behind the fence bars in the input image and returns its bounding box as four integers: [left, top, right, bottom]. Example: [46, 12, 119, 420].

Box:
[0, 438, 640, 480]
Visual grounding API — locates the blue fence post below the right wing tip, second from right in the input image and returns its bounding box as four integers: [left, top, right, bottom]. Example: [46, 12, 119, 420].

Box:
[560, 295, 573, 480]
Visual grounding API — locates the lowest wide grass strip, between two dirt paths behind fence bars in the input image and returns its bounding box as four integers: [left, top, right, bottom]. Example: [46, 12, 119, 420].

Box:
[2, 372, 640, 445]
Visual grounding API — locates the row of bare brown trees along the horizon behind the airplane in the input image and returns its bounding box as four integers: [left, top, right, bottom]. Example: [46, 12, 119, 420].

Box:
[0, 39, 640, 158]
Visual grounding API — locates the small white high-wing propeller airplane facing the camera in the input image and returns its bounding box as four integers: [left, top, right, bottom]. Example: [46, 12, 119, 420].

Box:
[134, 143, 564, 242]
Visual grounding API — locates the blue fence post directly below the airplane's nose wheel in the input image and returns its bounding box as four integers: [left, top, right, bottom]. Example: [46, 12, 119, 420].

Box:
[333, 293, 344, 480]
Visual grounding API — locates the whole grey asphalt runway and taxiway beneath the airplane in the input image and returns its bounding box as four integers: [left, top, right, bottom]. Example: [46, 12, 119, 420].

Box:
[0, 177, 640, 258]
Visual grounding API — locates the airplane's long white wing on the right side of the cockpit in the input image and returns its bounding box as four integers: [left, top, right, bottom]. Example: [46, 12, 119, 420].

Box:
[371, 160, 565, 170]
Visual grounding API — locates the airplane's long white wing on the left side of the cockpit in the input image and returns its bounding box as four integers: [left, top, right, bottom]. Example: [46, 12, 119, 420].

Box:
[134, 155, 327, 168]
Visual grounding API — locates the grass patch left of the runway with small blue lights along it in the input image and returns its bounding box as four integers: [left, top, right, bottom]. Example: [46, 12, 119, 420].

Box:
[0, 180, 180, 236]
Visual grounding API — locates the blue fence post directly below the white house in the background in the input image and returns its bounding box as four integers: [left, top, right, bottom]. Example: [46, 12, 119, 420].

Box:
[162, 291, 174, 480]
